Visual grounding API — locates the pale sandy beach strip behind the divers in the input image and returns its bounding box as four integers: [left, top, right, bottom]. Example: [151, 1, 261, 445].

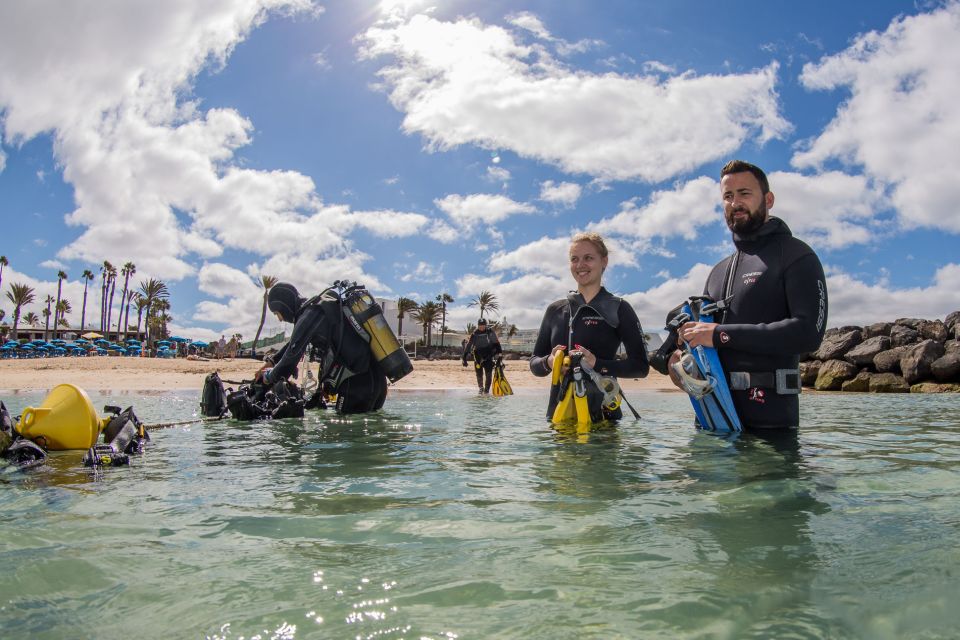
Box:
[0, 357, 676, 393]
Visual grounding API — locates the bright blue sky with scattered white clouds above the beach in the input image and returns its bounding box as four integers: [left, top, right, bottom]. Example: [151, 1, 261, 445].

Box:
[0, 0, 960, 339]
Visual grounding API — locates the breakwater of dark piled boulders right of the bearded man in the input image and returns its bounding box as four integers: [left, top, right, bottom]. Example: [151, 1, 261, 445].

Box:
[800, 311, 960, 393]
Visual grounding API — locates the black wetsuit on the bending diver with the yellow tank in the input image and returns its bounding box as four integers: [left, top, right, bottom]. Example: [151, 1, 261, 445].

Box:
[264, 300, 387, 413]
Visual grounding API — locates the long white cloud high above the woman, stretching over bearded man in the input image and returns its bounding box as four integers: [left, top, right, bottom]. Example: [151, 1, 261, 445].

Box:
[360, 14, 790, 181]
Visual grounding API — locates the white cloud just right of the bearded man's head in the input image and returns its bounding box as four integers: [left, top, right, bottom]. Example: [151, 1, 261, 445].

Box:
[769, 171, 886, 249]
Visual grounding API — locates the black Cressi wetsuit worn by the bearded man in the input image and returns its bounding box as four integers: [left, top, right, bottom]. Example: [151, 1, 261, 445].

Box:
[704, 217, 827, 429]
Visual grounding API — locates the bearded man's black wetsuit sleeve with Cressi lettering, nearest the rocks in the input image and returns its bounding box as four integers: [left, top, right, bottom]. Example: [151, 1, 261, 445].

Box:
[713, 253, 827, 355]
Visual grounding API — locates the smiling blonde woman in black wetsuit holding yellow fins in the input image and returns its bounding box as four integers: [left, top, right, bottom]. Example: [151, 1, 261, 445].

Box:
[530, 233, 650, 424]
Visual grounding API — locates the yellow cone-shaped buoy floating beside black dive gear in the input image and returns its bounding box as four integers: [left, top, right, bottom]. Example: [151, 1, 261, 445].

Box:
[16, 384, 103, 451]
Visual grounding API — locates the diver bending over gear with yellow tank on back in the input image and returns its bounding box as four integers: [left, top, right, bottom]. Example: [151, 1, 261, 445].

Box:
[256, 281, 413, 414]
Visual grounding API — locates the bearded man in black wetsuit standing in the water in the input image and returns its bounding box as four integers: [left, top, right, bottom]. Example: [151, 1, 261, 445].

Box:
[669, 160, 827, 430]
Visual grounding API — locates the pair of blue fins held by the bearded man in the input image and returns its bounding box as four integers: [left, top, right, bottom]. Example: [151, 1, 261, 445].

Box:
[667, 297, 743, 433]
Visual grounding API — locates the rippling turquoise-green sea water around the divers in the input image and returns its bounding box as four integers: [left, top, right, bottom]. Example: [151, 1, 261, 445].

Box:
[0, 392, 960, 639]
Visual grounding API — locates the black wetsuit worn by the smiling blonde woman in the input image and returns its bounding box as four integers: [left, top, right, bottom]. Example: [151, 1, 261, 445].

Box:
[530, 287, 650, 419]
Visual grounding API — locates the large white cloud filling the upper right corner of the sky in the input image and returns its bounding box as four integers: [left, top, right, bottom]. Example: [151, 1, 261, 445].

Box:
[792, 2, 960, 233]
